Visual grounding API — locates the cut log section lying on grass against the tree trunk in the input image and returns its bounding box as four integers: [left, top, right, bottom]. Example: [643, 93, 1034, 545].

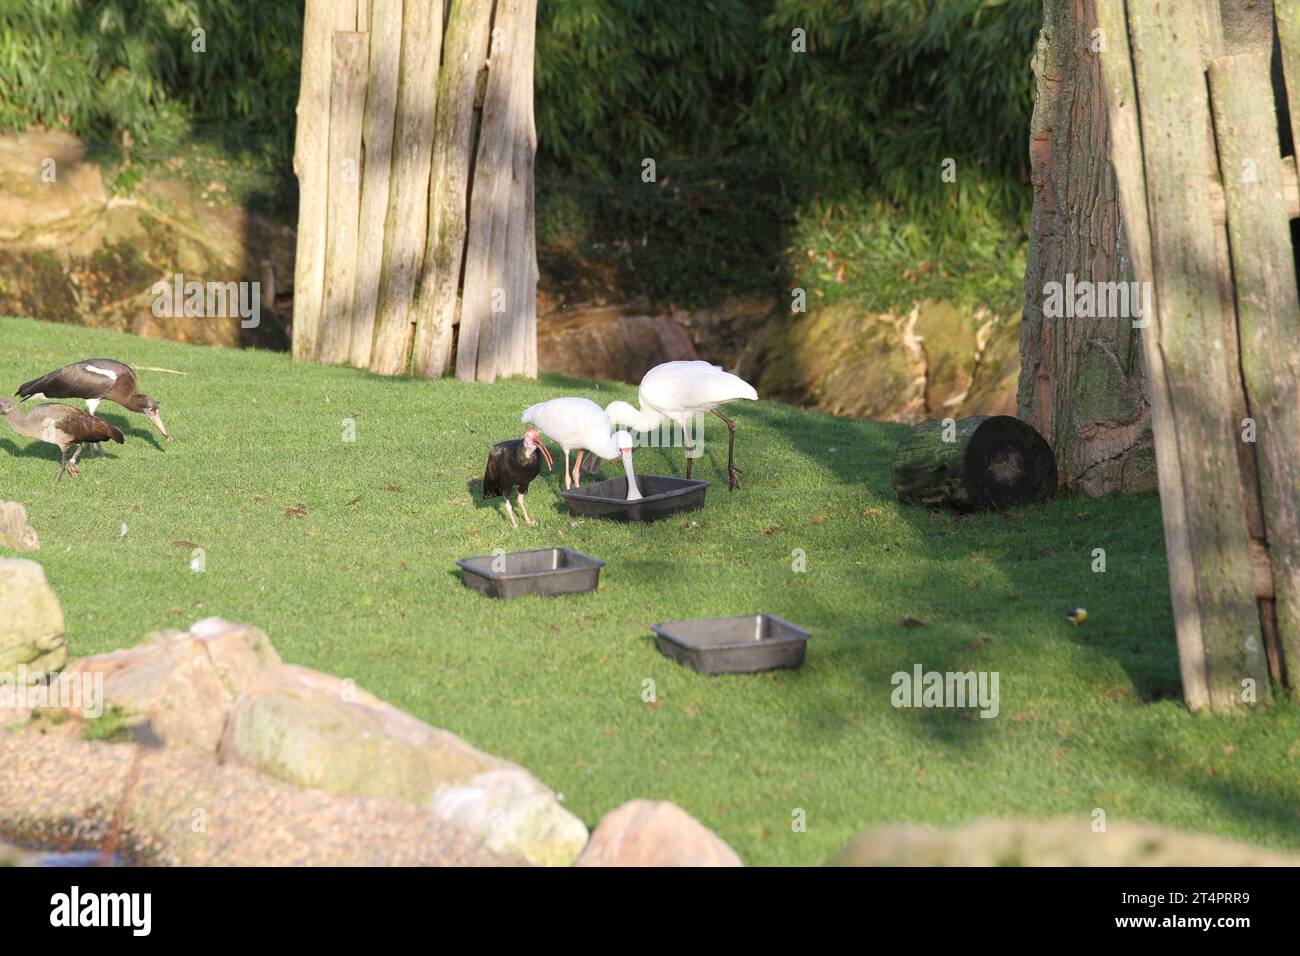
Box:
[893, 415, 1057, 511]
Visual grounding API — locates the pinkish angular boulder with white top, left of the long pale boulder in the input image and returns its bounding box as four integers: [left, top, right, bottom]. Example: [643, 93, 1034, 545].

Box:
[51, 618, 280, 753]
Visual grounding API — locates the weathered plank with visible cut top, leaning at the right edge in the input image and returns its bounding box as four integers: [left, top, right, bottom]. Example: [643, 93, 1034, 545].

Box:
[1209, 52, 1300, 697]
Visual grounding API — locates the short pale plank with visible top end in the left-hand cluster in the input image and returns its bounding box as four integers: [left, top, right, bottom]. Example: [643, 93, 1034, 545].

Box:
[319, 33, 369, 364]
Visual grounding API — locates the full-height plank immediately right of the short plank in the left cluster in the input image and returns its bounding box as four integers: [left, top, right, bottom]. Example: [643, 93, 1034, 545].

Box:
[348, 0, 402, 368]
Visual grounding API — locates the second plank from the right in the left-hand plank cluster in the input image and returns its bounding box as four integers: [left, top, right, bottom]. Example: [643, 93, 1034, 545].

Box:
[411, 0, 493, 378]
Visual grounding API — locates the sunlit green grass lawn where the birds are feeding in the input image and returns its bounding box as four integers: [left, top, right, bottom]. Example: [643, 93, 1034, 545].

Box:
[0, 319, 1300, 864]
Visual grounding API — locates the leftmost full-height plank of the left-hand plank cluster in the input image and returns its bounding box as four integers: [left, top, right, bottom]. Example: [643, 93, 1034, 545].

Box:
[293, 0, 334, 362]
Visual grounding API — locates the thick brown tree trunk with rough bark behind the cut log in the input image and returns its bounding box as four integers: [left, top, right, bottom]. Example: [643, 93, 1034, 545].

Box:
[1017, 0, 1156, 494]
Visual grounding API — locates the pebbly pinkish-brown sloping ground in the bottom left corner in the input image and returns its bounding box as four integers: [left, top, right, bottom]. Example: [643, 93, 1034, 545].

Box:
[0, 732, 524, 866]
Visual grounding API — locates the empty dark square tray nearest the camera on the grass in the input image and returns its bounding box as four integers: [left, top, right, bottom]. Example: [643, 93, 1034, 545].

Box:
[650, 614, 813, 674]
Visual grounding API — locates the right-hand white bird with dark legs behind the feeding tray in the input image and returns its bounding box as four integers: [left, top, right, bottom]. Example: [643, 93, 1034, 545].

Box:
[605, 362, 758, 490]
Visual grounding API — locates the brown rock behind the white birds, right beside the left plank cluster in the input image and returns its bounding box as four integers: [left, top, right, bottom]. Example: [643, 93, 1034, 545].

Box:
[537, 306, 699, 384]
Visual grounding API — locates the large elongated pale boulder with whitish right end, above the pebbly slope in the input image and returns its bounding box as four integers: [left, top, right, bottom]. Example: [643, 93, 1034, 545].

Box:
[220, 665, 586, 866]
